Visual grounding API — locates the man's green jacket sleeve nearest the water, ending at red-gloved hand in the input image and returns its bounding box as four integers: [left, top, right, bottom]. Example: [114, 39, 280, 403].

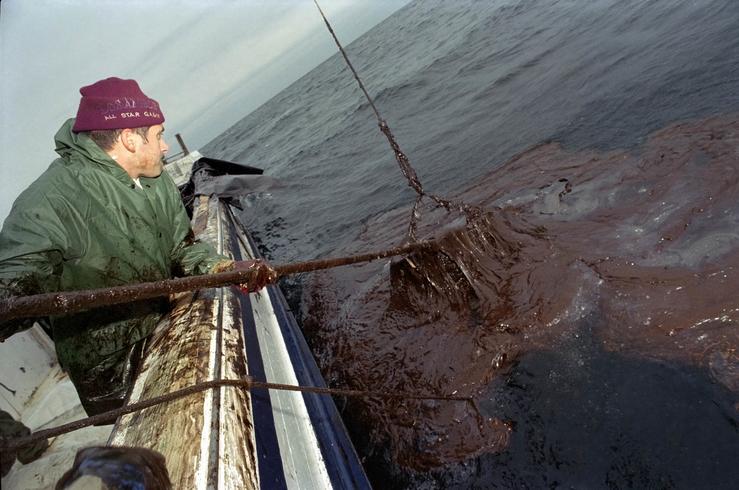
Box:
[162, 173, 233, 276]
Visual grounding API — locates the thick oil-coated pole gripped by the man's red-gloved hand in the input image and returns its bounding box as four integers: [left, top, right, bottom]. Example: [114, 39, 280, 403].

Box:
[0, 241, 433, 323]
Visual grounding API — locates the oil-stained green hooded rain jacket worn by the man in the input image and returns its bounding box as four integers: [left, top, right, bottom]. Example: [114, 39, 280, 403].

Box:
[0, 119, 227, 413]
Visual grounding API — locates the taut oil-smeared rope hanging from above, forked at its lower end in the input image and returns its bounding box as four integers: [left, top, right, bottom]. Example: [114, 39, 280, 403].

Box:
[313, 0, 478, 242]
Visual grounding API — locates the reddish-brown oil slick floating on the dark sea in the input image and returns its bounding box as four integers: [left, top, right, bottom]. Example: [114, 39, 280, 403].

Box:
[303, 117, 739, 481]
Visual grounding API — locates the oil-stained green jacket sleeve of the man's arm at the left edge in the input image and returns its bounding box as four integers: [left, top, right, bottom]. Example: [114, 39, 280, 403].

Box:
[0, 198, 69, 341]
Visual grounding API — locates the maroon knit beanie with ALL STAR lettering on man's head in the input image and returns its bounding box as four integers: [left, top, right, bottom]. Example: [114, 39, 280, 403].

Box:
[72, 77, 164, 133]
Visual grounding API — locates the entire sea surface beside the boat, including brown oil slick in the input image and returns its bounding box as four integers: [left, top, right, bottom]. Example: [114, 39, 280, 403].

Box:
[204, 0, 739, 489]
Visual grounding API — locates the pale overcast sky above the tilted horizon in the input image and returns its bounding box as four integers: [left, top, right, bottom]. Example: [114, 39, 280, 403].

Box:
[0, 0, 410, 221]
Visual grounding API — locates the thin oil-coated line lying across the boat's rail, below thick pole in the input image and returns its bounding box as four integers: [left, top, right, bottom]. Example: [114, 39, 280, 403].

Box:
[0, 377, 479, 451]
